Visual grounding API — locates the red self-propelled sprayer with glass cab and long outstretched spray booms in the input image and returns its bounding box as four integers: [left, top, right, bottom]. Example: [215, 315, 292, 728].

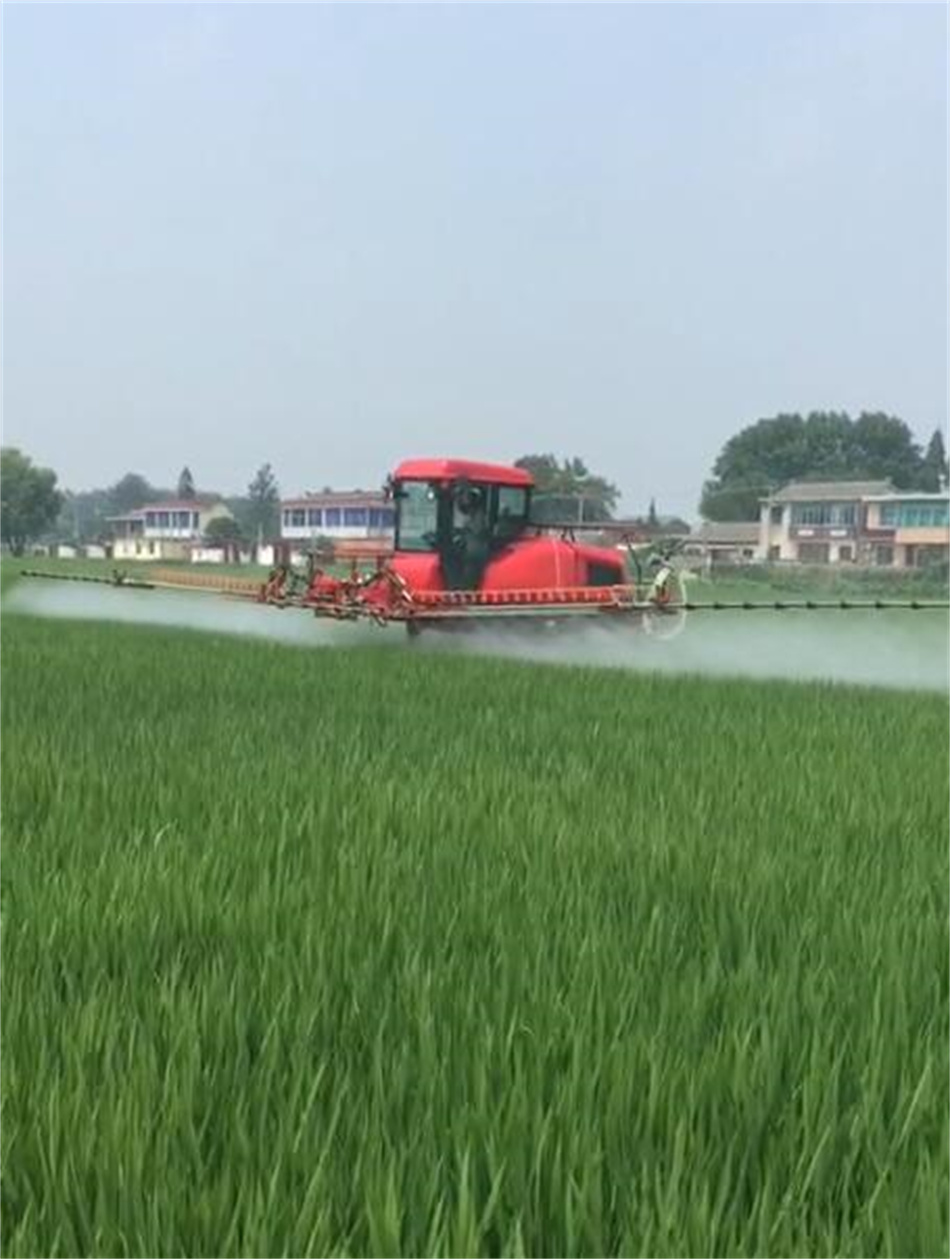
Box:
[26, 458, 949, 636]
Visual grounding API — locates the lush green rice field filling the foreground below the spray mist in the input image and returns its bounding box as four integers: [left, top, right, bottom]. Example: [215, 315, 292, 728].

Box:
[0, 574, 950, 1255]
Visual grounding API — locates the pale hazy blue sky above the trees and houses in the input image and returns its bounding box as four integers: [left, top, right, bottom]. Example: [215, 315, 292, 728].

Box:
[3, 4, 947, 514]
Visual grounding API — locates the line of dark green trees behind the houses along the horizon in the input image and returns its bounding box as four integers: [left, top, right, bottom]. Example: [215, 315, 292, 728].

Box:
[0, 410, 950, 553]
